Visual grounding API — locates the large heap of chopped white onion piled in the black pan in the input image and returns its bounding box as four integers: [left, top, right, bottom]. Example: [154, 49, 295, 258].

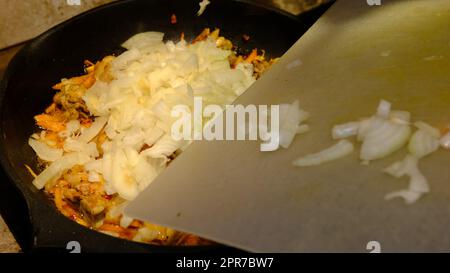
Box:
[29, 32, 270, 200]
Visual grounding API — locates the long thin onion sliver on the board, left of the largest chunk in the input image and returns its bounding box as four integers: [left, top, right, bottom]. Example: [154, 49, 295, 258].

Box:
[293, 139, 354, 167]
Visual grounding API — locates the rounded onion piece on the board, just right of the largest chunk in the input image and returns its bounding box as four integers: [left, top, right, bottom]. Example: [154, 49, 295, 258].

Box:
[408, 122, 439, 158]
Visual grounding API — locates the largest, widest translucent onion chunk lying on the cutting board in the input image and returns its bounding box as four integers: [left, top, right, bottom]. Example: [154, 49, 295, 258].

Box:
[360, 117, 411, 161]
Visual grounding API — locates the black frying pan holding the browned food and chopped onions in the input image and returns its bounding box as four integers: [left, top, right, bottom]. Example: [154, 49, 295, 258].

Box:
[0, 0, 329, 252]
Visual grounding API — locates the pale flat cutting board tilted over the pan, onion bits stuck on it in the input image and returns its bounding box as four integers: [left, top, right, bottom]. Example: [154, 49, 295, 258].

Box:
[126, 0, 450, 252]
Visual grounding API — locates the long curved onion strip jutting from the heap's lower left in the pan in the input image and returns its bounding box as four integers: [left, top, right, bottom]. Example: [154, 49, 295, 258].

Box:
[33, 153, 90, 189]
